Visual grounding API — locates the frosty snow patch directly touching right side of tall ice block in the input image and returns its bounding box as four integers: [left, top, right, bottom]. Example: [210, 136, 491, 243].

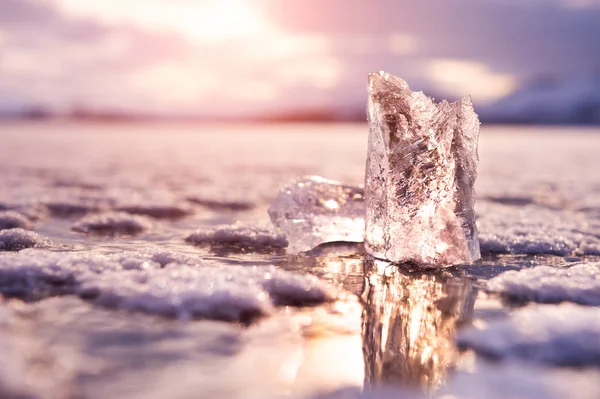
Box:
[477, 202, 600, 256]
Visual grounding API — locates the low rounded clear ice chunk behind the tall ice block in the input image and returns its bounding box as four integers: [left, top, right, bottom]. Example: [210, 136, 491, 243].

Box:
[269, 176, 365, 253]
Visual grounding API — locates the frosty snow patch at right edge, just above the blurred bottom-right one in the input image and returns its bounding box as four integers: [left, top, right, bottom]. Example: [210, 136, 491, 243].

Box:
[486, 262, 600, 306]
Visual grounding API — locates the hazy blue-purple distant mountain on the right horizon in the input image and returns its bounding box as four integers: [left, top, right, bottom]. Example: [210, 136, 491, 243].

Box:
[479, 74, 600, 125]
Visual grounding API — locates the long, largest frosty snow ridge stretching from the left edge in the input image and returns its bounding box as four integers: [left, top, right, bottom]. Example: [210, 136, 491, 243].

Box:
[0, 250, 338, 321]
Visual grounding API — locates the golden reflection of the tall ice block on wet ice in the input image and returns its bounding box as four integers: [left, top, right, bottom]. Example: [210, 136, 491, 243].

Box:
[362, 258, 475, 389]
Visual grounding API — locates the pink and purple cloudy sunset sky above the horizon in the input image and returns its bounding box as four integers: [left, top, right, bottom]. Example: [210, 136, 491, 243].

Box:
[0, 0, 600, 115]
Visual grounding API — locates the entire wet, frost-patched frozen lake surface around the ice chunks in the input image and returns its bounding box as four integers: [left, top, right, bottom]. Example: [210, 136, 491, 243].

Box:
[0, 124, 600, 399]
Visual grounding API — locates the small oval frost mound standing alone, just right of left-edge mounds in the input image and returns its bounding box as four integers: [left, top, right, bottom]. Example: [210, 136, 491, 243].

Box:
[71, 212, 152, 235]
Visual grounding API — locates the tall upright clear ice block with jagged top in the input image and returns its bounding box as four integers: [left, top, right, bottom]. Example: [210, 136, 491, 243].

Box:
[365, 72, 480, 266]
